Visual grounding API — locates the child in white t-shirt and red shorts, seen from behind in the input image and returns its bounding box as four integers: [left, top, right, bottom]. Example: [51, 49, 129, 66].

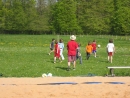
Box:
[107, 39, 115, 63]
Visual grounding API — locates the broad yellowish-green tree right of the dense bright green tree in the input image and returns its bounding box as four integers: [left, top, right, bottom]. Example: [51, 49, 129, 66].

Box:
[77, 0, 112, 34]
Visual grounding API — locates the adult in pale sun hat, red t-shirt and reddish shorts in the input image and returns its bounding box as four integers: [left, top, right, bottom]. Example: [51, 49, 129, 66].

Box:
[67, 35, 78, 71]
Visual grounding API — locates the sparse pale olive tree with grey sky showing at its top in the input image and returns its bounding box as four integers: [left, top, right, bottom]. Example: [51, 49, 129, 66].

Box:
[30, 0, 49, 34]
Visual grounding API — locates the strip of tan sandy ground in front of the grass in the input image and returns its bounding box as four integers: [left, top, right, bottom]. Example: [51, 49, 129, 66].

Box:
[0, 77, 130, 98]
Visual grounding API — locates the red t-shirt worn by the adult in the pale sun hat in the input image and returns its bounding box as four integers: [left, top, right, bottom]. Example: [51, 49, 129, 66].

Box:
[67, 40, 78, 56]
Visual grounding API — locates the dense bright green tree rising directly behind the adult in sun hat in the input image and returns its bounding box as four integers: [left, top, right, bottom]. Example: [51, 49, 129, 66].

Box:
[52, 0, 82, 34]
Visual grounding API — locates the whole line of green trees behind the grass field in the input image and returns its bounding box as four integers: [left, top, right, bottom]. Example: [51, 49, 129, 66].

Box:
[0, 0, 130, 35]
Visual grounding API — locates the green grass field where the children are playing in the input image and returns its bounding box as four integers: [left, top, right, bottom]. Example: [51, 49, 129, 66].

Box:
[0, 35, 130, 77]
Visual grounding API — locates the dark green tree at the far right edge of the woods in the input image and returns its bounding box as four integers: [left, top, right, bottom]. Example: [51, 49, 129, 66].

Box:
[111, 0, 130, 35]
